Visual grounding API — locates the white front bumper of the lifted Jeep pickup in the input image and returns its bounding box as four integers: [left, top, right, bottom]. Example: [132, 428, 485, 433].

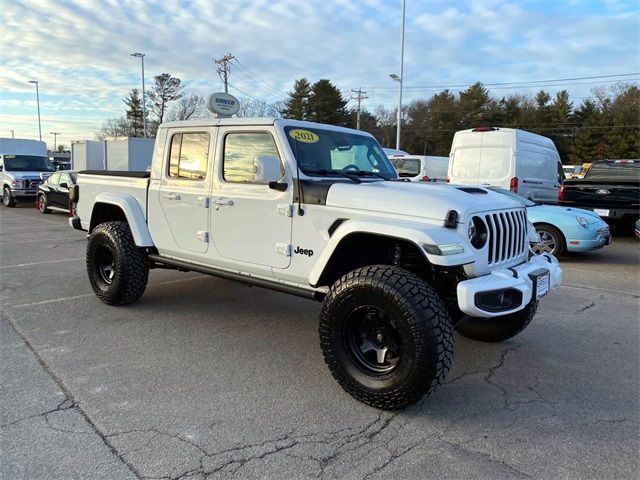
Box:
[457, 253, 562, 318]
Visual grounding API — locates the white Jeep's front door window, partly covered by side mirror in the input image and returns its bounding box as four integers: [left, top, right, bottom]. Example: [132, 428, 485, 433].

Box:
[222, 132, 284, 183]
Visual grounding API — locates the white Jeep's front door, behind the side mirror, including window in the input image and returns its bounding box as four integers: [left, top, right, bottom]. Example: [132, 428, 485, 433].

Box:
[211, 127, 293, 268]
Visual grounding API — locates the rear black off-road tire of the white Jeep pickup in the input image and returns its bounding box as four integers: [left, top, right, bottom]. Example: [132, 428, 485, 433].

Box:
[86, 222, 149, 305]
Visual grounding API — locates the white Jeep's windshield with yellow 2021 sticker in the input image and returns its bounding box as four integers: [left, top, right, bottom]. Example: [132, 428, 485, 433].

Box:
[285, 127, 396, 179]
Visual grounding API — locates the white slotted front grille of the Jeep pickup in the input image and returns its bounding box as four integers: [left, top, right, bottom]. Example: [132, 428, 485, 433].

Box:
[484, 210, 527, 265]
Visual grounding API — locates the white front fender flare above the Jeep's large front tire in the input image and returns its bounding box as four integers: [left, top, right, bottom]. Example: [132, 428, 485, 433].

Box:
[309, 219, 475, 286]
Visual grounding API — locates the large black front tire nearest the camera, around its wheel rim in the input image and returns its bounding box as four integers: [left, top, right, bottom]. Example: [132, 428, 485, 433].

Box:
[319, 265, 453, 410]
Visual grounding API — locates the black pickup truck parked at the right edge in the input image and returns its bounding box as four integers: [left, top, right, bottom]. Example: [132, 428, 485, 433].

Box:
[558, 160, 640, 225]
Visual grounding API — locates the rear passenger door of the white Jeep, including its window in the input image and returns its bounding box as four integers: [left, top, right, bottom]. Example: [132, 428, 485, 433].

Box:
[158, 129, 212, 255]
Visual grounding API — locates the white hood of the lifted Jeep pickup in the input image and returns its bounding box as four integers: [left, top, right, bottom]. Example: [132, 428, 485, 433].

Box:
[326, 181, 522, 221]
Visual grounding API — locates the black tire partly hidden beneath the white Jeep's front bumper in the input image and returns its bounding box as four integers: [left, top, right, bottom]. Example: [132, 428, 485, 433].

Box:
[455, 300, 538, 343]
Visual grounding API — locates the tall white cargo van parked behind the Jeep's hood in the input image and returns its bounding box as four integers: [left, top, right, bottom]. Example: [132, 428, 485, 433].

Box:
[448, 127, 564, 203]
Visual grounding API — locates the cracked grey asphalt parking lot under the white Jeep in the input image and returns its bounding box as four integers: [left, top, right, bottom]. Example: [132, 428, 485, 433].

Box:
[0, 206, 640, 479]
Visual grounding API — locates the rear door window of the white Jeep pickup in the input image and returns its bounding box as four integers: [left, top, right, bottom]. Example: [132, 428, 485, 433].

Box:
[169, 132, 209, 180]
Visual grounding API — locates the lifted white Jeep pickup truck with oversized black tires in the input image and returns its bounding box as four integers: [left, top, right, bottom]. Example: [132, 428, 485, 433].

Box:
[70, 118, 561, 409]
